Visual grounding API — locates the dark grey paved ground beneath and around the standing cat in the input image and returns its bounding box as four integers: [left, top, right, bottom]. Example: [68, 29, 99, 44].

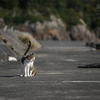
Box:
[0, 41, 100, 100]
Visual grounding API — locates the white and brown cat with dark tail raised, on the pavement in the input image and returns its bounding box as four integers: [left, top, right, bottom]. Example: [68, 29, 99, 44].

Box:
[20, 41, 36, 77]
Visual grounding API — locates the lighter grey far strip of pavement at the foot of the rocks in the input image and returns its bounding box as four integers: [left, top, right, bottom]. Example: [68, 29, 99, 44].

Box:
[39, 41, 93, 51]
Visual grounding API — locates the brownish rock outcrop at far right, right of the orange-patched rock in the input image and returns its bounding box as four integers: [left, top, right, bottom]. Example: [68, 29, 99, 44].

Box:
[70, 24, 100, 41]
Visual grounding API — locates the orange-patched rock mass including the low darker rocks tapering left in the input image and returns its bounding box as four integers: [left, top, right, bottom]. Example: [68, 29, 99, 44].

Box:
[15, 15, 70, 40]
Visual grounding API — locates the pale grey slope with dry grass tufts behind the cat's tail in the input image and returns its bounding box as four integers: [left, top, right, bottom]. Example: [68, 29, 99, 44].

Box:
[0, 29, 41, 56]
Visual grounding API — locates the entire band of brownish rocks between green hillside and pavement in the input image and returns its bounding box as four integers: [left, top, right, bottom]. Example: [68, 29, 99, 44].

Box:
[15, 15, 100, 41]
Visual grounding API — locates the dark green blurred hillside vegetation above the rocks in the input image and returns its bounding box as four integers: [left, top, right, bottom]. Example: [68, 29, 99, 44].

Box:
[0, 0, 100, 29]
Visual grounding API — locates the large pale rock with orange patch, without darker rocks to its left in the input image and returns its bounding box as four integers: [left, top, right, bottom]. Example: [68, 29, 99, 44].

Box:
[34, 15, 70, 40]
